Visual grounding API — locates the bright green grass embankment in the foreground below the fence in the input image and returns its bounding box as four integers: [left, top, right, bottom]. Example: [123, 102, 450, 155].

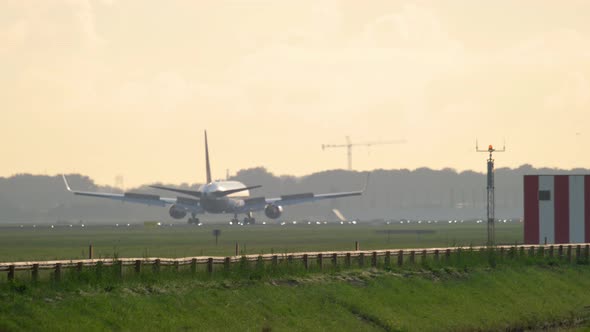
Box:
[0, 260, 590, 331]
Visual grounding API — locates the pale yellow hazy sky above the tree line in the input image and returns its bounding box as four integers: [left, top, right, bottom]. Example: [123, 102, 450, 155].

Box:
[0, 0, 590, 187]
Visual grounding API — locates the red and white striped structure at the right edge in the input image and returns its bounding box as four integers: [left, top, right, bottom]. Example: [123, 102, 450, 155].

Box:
[524, 175, 590, 244]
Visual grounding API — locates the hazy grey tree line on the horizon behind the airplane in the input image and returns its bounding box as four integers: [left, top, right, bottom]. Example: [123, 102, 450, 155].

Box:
[0, 165, 590, 223]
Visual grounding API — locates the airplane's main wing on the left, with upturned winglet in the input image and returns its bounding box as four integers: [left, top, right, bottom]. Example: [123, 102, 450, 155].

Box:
[62, 175, 203, 213]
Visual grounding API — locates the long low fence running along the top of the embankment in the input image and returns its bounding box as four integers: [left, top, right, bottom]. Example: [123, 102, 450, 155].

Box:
[0, 242, 590, 280]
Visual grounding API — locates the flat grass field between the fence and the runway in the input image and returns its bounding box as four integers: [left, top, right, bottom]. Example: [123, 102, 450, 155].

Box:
[0, 222, 523, 262]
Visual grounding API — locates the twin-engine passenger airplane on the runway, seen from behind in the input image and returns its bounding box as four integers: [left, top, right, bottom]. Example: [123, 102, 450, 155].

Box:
[62, 131, 369, 225]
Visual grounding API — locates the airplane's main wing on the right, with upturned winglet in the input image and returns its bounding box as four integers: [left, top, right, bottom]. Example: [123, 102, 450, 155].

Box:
[243, 174, 369, 211]
